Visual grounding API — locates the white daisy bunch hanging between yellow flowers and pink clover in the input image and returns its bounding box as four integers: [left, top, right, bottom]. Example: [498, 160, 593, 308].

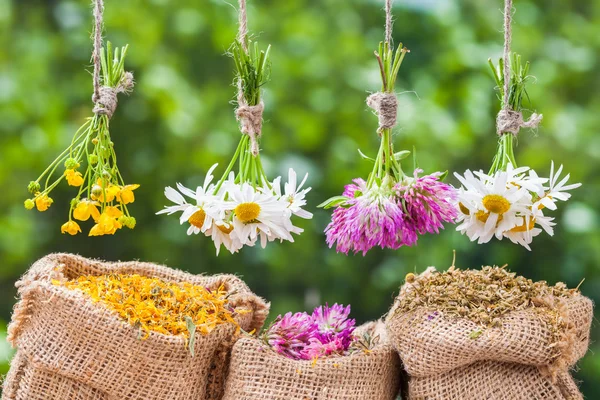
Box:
[157, 41, 312, 255]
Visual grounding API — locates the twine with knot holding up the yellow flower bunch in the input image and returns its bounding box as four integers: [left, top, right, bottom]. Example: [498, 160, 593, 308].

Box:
[92, 0, 134, 118]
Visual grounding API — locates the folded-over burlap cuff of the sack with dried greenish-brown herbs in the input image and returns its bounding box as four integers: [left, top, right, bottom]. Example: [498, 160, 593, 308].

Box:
[386, 295, 593, 377]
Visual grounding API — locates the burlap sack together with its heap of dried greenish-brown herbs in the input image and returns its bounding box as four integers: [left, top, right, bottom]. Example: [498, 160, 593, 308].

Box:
[386, 267, 593, 399]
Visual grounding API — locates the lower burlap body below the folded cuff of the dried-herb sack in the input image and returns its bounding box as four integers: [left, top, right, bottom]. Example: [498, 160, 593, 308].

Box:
[409, 361, 583, 400]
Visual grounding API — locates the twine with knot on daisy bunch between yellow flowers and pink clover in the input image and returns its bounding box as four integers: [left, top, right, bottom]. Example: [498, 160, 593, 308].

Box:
[235, 0, 265, 157]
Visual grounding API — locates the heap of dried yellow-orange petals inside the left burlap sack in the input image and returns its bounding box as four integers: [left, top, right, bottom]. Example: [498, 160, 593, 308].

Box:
[52, 274, 237, 338]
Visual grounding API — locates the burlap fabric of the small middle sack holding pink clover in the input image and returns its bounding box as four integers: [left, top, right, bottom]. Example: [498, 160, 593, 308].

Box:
[223, 323, 400, 400]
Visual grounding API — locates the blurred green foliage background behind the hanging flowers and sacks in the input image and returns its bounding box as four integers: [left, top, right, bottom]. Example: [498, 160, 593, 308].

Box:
[0, 0, 600, 398]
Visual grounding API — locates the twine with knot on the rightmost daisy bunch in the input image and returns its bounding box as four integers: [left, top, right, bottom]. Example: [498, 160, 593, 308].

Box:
[496, 0, 542, 136]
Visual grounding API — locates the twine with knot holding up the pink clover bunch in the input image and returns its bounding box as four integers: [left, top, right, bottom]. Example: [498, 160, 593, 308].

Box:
[367, 0, 398, 135]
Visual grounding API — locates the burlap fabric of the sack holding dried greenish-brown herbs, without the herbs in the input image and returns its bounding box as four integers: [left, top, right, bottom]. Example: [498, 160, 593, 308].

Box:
[386, 269, 593, 400]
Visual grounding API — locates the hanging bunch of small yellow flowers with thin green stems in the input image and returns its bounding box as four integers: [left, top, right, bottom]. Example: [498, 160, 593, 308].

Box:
[25, 42, 139, 236]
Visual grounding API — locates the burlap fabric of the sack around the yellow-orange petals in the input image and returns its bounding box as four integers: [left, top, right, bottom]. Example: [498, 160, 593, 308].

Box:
[2, 254, 268, 400]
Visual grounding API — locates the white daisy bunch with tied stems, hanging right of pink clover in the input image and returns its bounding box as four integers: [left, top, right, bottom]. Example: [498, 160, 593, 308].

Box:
[455, 54, 581, 250]
